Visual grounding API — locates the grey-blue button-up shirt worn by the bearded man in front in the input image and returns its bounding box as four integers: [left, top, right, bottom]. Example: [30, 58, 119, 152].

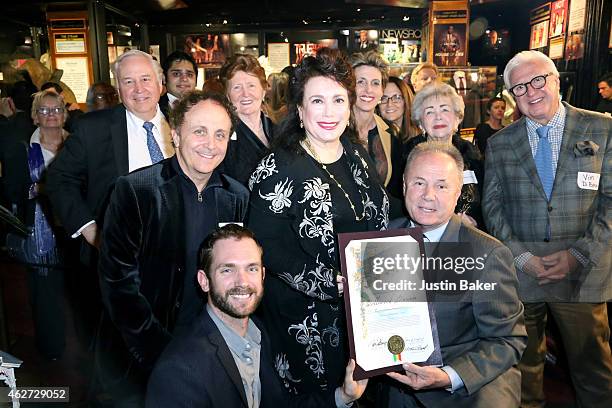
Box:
[206, 305, 261, 408]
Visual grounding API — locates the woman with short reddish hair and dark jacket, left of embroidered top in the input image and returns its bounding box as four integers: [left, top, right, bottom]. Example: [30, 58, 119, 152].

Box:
[219, 54, 274, 186]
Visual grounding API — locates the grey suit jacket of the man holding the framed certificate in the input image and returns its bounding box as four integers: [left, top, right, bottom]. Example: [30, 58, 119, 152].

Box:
[389, 215, 527, 408]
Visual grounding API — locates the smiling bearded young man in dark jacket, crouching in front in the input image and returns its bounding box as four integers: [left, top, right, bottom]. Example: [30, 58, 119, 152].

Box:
[146, 224, 368, 408]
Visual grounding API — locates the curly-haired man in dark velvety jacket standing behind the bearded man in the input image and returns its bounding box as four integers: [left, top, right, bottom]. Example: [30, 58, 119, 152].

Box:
[96, 92, 248, 406]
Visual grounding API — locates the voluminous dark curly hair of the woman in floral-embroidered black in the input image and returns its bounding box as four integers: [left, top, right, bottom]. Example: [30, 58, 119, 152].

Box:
[274, 47, 357, 154]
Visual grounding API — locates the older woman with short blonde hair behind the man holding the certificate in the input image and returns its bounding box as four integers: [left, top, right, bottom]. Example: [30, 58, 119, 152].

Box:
[406, 82, 484, 229]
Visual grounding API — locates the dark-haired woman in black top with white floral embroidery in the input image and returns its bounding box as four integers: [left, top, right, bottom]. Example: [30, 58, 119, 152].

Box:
[248, 48, 389, 394]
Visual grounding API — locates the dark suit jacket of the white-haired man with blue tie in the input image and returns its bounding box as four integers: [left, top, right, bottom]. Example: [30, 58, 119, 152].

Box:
[47, 105, 129, 264]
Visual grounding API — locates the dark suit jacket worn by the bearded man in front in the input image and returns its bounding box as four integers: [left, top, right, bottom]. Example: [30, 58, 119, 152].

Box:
[146, 310, 336, 408]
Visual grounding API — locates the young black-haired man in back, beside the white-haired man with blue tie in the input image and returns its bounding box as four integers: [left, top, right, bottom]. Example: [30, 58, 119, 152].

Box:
[159, 51, 198, 119]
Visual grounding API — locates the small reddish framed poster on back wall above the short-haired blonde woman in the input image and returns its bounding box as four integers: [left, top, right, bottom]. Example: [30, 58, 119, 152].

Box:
[433, 24, 467, 67]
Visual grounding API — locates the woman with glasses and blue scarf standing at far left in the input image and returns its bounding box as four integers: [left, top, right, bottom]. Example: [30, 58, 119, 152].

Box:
[4, 90, 68, 359]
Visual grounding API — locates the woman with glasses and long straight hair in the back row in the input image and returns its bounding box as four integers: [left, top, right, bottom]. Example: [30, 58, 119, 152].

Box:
[378, 77, 419, 143]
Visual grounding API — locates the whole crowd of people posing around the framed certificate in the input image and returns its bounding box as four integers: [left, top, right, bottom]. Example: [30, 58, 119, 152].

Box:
[0, 48, 612, 408]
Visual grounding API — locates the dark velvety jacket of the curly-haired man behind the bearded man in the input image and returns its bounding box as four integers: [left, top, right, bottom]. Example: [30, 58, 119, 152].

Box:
[98, 157, 248, 388]
